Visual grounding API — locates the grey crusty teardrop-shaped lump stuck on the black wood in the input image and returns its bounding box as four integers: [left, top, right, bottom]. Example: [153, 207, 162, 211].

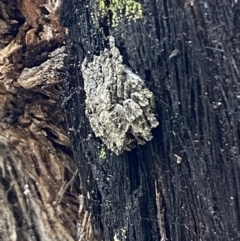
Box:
[81, 37, 159, 155]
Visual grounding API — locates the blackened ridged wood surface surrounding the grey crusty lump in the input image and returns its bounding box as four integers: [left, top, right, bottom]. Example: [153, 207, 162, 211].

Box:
[62, 0, 240, 241]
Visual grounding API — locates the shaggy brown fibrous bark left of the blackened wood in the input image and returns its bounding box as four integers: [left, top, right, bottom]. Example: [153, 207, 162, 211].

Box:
[0, 0, 85, 241]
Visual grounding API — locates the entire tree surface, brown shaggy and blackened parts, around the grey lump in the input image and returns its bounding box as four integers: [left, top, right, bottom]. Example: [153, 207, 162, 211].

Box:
[0, 0, 240, 241]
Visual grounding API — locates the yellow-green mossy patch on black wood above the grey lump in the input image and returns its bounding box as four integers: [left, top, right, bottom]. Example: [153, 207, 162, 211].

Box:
[97, 0, 143, 27]
